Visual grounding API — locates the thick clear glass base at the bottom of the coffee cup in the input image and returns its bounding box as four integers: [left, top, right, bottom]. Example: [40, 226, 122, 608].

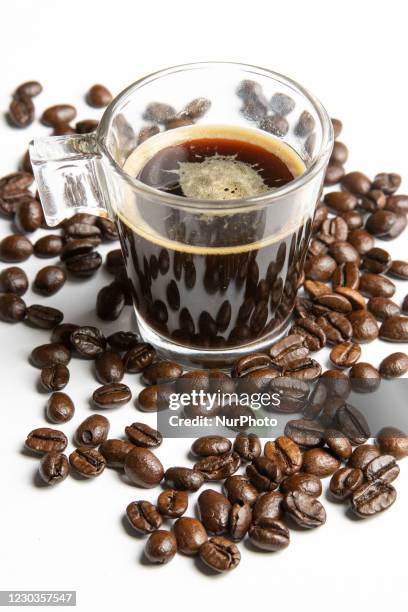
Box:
[136, 312, 292, 370]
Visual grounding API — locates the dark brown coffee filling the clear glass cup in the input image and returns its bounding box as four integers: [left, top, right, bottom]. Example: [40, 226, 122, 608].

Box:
[118, 129, 311, 349]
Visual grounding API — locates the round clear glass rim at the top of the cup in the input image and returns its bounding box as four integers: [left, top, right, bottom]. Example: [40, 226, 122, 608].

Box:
[96, 61, 334, 212]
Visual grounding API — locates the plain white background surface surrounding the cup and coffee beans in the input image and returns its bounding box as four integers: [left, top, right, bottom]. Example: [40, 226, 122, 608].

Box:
[0, 0, 408, 612]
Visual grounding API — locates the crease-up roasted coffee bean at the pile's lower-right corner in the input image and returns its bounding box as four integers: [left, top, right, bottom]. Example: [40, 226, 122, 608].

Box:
[351, 480, 397, 518]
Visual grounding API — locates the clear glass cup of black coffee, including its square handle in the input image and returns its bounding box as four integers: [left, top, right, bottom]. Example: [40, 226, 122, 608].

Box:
[30, 62, 333, 367]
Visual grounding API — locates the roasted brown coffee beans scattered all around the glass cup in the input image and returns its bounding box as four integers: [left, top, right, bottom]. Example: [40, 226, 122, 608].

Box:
[0, 81, 408, 572]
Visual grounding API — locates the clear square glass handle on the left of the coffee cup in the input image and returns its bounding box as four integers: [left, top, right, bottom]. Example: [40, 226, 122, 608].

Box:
[29, 134, 108, 227]
